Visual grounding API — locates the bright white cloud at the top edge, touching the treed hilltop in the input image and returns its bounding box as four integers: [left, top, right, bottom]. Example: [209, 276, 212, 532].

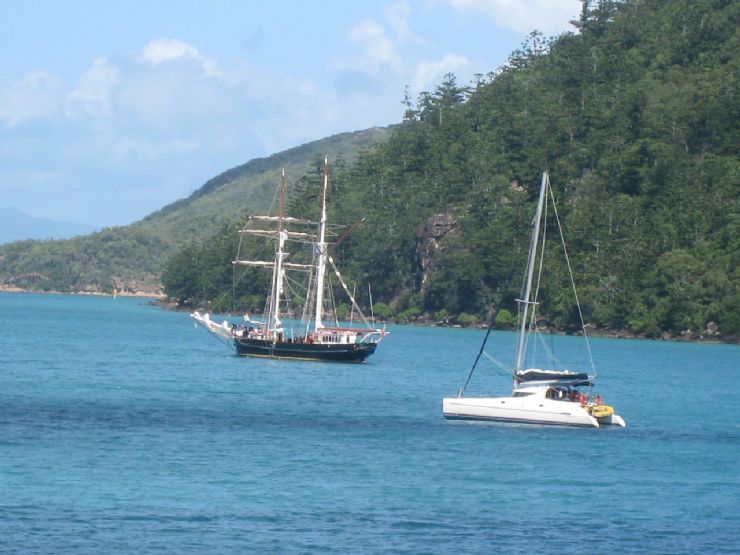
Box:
[440, 0, 581, 35]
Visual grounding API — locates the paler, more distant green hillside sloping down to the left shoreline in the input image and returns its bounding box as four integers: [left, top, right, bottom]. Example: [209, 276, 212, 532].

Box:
[0, 129, 390, 294]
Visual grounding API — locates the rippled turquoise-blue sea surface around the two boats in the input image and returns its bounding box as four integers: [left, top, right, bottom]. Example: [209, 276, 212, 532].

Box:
[0, 293, 740, 555]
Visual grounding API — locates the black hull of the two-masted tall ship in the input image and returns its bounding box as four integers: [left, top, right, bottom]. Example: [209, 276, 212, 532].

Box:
[234, 337, 378, 362]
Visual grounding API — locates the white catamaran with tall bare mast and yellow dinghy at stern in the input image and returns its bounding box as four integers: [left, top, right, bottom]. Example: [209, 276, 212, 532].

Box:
[442, 172, 626, 428]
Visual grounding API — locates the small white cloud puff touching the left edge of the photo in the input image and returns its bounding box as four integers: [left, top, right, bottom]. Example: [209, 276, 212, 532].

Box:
[0, 71, 62, 127]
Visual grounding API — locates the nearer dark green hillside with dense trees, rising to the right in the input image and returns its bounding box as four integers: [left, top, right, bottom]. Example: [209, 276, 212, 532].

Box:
[165, 0, 740, 337]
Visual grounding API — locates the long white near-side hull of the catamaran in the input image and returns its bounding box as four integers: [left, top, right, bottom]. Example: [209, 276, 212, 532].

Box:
[442, 397, 600, 428]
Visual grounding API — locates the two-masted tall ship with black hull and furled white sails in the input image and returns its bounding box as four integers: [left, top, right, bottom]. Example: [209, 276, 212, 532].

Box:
[191, 159, 388, 362]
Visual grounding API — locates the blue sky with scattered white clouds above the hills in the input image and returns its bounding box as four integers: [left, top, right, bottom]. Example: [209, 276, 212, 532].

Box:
[0, 0, 581, 227]
